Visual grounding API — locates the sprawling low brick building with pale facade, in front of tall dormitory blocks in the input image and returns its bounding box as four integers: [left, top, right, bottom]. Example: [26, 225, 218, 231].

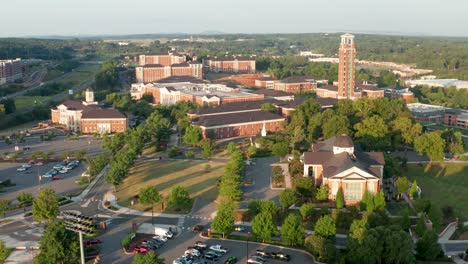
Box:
[131, 76, 264, 106]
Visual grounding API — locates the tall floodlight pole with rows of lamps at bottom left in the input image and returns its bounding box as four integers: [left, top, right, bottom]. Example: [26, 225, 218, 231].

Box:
[61, 211, 94, 264]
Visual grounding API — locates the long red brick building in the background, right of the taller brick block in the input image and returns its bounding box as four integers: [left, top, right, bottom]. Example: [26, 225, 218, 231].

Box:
[203, 56, 256, 73]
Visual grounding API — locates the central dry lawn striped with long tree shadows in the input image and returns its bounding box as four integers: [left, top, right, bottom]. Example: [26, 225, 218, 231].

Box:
[116, 160, 224, 211]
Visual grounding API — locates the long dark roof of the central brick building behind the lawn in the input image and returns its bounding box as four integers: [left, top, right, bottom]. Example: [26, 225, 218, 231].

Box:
[194, 110, 285, 127]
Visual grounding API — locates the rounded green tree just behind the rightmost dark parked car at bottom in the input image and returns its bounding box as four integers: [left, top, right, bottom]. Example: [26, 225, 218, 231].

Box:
[281, 214, 305, 246]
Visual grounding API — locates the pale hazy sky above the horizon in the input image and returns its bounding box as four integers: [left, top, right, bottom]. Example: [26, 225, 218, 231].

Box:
[0, 0, 468, 37]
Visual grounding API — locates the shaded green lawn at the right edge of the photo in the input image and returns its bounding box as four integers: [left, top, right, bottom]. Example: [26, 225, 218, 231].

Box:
[406, 163, 468, 219]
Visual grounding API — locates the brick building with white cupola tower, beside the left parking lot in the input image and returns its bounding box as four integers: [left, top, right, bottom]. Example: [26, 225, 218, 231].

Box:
[51, 89, 127, 134]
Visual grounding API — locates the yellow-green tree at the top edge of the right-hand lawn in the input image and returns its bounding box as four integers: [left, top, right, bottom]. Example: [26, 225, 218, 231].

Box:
[414, 131, 445, 161]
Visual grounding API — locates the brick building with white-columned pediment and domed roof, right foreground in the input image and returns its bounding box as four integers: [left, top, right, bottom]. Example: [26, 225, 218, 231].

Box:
[304, 135, 385, 205]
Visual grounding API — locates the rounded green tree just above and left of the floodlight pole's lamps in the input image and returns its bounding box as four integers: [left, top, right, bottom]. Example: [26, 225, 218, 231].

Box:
[32, 189, 59, 223]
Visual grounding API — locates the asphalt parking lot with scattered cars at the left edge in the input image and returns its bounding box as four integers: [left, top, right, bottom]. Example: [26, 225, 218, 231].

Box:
[0, 159, 86, 200]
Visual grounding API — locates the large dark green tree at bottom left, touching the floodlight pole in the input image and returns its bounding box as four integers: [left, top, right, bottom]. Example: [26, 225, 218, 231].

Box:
[34, 220, 80, 264]
